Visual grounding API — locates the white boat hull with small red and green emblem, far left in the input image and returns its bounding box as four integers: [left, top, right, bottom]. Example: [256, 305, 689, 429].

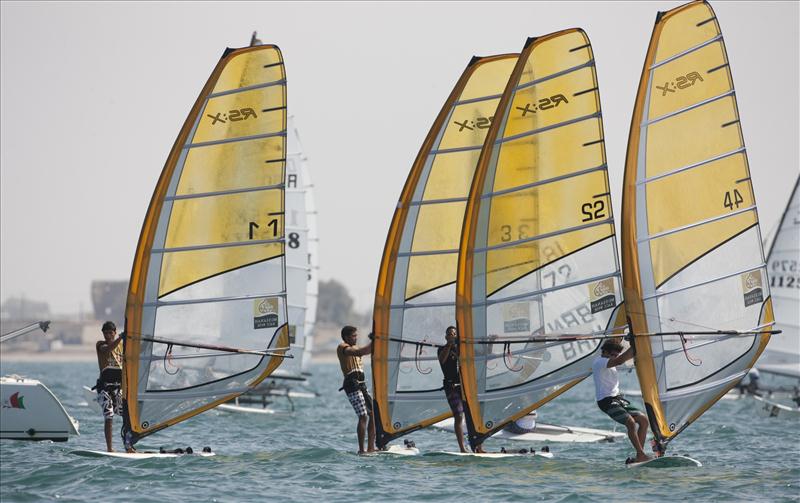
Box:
[0, 376, 79, 442]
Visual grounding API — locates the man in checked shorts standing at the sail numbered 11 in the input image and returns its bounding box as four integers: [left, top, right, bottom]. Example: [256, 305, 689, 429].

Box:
[94, 321, 133, 452]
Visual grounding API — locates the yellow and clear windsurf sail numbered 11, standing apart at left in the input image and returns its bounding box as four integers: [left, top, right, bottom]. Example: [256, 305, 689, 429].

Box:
[123, 45, 289, 445]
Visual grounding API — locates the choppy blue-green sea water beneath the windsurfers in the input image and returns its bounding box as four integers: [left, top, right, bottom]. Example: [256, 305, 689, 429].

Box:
[0, 362, 800, 502]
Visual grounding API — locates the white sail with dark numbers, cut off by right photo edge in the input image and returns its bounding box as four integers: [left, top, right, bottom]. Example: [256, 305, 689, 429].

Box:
[756, 177, 800, 378]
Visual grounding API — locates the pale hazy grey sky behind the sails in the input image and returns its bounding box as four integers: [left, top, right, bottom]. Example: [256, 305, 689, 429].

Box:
[0, 1, 800, 312]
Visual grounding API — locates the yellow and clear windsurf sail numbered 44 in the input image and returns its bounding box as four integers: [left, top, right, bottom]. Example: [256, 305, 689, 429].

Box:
[622, 1, 773, 446]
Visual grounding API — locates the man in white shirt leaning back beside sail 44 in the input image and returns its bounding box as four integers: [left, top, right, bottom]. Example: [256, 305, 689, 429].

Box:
[592, 340, 650, 463]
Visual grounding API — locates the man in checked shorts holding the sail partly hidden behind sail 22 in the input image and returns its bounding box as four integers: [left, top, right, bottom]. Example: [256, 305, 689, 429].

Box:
[336, 325, 375, 454]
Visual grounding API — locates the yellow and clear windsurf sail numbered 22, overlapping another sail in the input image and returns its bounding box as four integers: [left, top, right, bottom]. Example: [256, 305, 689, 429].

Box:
[457, 29, 622, 449]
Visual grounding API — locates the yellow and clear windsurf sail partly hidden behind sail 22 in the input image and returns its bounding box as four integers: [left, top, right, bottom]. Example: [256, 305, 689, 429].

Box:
[372, 54, 517, 448]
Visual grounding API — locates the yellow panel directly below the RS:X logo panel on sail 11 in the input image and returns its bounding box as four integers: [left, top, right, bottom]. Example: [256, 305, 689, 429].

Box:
[176, 136, 284, 195]
